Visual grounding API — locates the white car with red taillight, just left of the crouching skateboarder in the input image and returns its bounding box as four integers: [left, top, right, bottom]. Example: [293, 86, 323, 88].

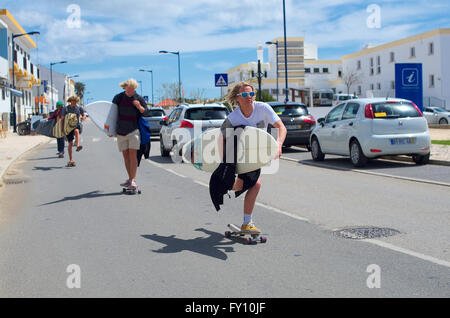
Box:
[159, 104, 229, 157]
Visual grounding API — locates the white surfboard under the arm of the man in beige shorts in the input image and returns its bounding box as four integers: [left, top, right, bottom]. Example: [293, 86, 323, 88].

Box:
[84, 101, 118, 136]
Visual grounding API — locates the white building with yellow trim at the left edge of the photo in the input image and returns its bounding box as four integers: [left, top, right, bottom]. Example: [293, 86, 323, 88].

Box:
[0, 9, 40, 122]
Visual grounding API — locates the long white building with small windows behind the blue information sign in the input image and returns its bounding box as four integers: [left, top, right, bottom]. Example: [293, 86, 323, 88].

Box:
[342, 29, 450, 107]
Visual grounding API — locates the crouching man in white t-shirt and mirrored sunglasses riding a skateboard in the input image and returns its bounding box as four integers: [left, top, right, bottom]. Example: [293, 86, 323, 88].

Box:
[221, 82, 287, 234]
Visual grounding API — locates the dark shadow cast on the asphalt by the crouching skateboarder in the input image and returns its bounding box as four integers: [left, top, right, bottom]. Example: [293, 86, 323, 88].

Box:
[142, 228, 236, 261]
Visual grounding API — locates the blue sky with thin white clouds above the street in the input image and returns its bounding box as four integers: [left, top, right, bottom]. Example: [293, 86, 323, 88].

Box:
[0, 0, 450, 103]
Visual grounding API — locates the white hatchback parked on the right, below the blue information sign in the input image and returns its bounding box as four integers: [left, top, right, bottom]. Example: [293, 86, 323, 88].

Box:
[311, 98, 431, 167]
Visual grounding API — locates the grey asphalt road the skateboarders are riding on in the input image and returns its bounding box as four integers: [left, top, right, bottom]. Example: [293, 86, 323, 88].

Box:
[0, 118, 450, 297]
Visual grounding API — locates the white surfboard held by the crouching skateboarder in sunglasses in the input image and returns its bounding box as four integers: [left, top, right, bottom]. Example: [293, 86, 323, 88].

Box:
[182, 127, 278, 174]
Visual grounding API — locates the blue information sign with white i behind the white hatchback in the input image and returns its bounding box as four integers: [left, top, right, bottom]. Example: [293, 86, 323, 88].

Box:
[395, 63, 423, 111]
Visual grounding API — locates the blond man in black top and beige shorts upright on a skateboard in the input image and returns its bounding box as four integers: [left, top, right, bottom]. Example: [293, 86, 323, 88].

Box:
[112, 79, 147, 190]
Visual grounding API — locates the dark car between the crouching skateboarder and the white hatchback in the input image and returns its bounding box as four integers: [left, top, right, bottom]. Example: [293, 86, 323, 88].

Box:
[268, 102, 316, 150]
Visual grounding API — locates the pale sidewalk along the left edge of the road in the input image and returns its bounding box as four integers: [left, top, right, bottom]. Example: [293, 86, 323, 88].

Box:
[0, 130, 51, 186]
